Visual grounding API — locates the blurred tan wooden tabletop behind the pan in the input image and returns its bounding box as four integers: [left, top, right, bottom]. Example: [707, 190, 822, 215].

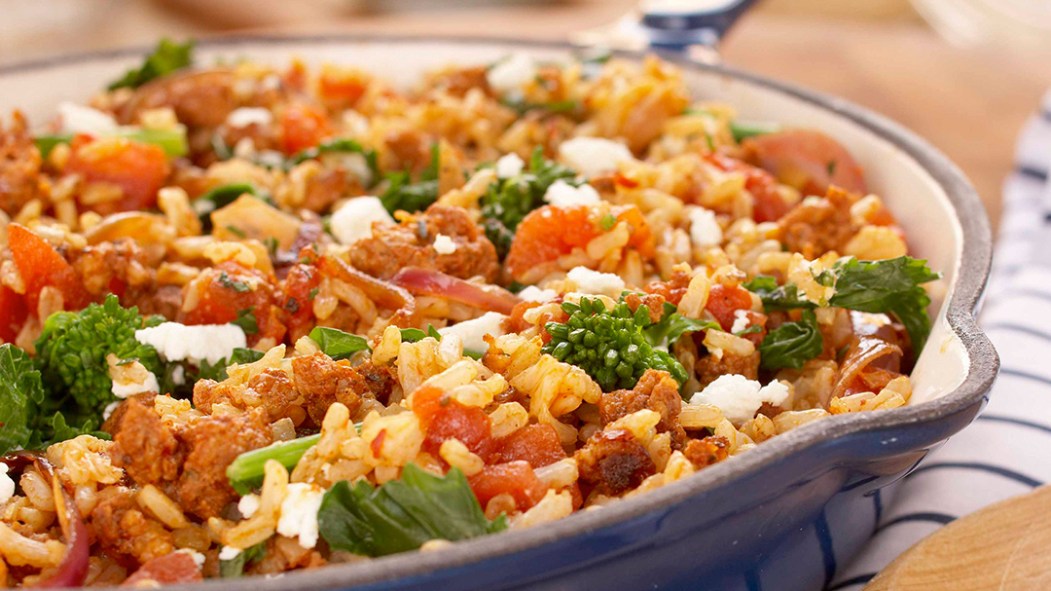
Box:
[0, 0, 1051, 228]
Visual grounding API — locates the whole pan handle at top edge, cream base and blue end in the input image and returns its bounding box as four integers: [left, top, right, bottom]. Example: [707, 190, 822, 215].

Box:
[571, 0, 756, 62]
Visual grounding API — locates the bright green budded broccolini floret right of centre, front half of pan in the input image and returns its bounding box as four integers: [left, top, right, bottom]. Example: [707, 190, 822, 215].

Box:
[542, 297, 700, 391]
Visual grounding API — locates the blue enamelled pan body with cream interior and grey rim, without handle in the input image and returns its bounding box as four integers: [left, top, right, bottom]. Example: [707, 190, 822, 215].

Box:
[0, 37, 998, 591]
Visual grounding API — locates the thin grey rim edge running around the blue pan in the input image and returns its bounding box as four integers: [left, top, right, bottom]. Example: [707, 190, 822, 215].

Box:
[0, 33, 1000, 591]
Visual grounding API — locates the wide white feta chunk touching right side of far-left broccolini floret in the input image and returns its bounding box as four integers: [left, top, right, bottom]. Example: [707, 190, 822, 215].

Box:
[135, 322, 248, 365]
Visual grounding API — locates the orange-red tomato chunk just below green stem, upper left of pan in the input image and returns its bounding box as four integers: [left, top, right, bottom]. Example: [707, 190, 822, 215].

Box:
[66, 136, 171, 213]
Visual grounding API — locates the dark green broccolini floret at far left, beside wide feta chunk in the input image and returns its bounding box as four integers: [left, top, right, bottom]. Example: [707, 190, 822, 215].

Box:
[37, 294, 163, 423]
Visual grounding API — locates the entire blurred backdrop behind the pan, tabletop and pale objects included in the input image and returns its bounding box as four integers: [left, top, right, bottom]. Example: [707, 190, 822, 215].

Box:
[0, 0, 1051, 224]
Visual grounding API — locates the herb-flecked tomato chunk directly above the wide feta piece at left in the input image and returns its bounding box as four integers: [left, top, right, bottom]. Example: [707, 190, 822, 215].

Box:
[179, 261, 286, 344]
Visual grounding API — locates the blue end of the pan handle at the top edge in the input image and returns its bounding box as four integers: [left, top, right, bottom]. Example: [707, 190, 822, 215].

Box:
[639, 0, 756, 52]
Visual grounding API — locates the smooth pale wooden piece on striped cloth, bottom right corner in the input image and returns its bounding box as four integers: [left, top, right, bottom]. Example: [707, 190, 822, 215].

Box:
[865, 485, 1051, 591]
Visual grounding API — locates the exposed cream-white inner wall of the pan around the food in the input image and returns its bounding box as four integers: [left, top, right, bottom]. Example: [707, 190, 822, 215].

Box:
[0, 39, 968, 404]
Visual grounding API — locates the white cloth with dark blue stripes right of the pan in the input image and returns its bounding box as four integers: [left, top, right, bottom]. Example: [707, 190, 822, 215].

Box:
[828, 93, 1051, 591]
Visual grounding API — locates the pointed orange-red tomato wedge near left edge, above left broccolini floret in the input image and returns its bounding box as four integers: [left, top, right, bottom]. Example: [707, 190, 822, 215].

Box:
[7, 224, 91, 312]
